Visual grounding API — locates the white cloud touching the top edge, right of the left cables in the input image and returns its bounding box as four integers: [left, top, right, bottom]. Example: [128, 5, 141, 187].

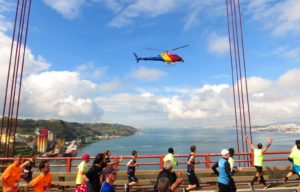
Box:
[43, 0, 86, 19]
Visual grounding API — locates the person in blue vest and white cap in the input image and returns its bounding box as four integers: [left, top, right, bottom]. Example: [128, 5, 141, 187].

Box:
[212, 149, 231, 192]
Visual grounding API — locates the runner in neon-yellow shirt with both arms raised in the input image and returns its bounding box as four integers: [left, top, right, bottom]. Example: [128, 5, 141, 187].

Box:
[246, 135, 273, 191]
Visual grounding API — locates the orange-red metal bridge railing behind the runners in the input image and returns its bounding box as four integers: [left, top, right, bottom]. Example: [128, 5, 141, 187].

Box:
[0, 151, 290, 172]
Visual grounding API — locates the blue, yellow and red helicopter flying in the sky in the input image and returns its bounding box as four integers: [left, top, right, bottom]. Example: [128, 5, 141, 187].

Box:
[133, 45, 189, 65]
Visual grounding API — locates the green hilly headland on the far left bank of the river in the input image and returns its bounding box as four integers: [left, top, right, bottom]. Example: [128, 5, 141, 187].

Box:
[0, 119, 137, 140]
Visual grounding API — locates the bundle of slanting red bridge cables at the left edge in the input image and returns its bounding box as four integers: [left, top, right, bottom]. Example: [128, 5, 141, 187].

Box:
[0, 0, 31, 157]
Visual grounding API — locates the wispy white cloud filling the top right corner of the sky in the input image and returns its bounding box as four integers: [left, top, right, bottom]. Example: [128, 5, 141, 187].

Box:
[248, 0, 300, 36]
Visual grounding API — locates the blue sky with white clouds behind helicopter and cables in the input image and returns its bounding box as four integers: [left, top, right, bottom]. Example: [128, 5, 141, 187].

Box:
[0, 0, 300, 128]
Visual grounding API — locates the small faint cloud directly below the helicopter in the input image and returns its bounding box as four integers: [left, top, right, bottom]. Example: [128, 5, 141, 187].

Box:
[131, 67, 167, 81]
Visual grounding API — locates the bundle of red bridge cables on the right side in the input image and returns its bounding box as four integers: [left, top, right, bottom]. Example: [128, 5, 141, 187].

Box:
[226, 0, 252, 166]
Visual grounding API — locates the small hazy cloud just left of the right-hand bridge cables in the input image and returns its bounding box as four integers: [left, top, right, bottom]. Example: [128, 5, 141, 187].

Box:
[207, 32, 229, 55]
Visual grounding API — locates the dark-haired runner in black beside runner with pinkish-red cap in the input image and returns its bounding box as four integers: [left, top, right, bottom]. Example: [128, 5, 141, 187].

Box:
[85, 153, 104, 192]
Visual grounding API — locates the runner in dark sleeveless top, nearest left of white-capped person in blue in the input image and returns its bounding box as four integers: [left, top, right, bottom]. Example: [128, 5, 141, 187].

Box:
[186, 145, 200, 191]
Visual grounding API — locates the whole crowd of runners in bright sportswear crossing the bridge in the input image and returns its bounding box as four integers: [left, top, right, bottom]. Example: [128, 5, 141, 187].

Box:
[0, 136, 300, 192]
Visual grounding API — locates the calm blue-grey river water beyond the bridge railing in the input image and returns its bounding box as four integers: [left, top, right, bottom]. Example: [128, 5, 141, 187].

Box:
[74, 128, 300, 169]
